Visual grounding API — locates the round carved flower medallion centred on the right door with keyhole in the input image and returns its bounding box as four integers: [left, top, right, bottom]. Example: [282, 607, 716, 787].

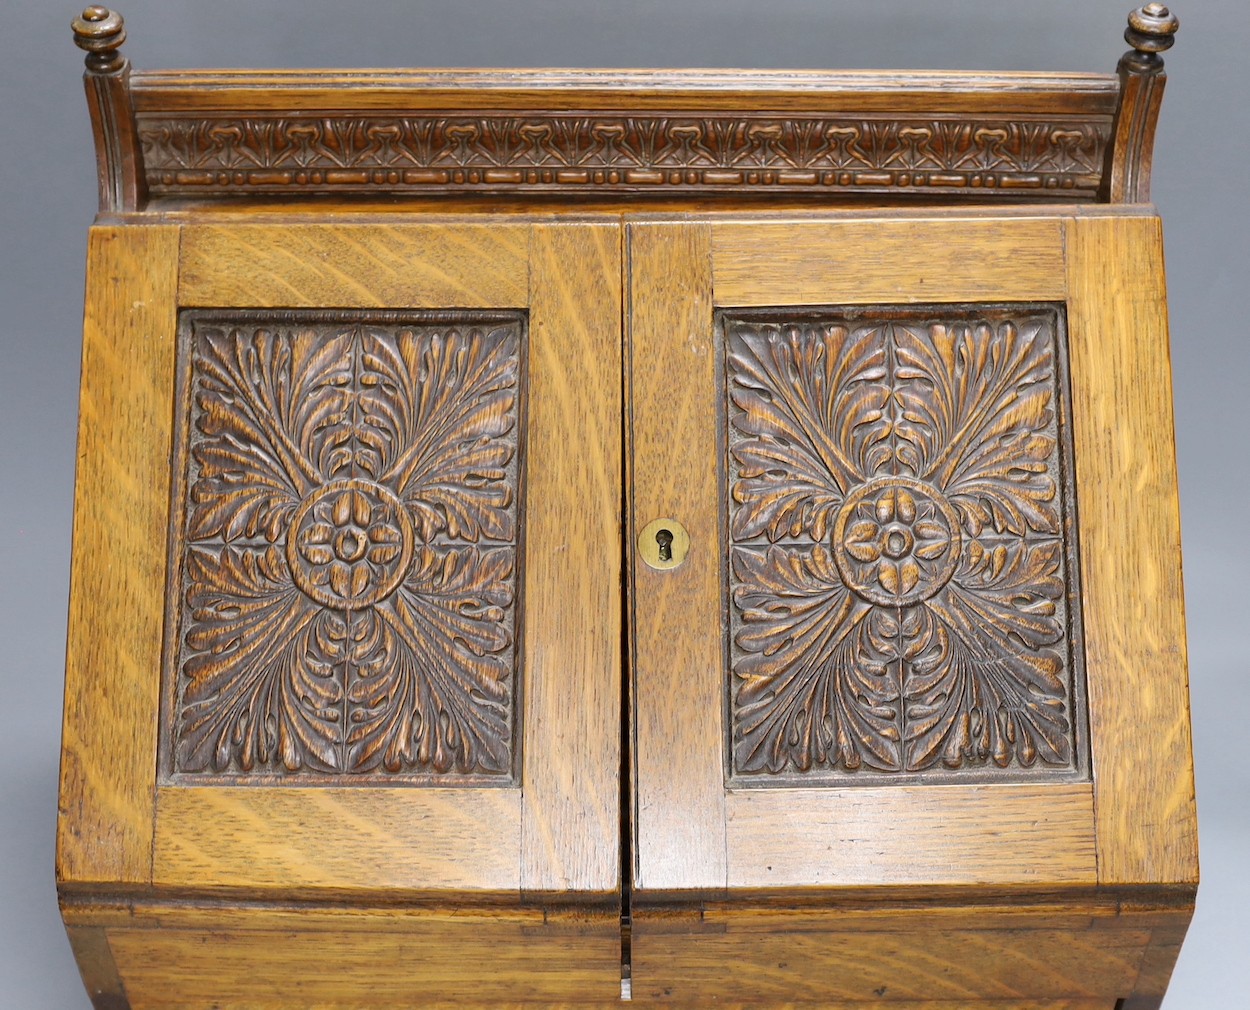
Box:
[833, 476, 960, 606]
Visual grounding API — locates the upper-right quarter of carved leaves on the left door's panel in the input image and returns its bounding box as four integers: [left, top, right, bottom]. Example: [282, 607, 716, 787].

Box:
[367, 329, 519, 541]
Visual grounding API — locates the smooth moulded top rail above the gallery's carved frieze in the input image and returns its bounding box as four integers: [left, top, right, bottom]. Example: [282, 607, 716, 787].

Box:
[131, 69, 1119, 115]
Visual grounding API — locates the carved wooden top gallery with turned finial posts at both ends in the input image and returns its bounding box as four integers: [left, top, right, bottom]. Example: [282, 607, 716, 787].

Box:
[75, 4, 1175, 211]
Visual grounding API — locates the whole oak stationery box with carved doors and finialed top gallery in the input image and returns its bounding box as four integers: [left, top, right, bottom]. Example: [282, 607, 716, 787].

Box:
[56, 4, 1198, 1010]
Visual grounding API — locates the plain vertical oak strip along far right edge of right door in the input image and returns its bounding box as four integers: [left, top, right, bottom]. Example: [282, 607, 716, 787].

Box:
[1068, 216, 1198, 884]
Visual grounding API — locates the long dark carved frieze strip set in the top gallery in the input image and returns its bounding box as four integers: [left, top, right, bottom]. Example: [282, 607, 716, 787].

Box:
[139, 113, 1111, 199]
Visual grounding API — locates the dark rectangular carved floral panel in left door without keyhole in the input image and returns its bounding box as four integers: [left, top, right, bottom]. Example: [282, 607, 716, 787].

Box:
[166, 313, 524, 783]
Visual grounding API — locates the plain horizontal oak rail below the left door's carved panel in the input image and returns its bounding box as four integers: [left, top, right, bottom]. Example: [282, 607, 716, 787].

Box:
[153, 786, 520, 893]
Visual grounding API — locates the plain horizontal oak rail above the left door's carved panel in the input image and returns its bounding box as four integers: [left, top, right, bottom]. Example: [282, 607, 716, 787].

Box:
[178, 224, 529, 309]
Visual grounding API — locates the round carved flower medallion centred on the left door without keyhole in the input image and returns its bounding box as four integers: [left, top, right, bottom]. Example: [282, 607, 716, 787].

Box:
[286, 478, 414, 610]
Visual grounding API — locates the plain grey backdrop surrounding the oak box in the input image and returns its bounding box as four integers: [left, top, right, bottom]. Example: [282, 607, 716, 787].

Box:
[0, 0, 1250, 1010]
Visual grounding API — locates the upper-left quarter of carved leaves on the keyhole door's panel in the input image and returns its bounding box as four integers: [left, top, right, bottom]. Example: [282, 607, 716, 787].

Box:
[729, 325, 888, 541]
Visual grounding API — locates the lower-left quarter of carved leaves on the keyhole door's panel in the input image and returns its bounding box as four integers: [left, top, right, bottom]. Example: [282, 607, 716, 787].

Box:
[731, 546, 903, 774]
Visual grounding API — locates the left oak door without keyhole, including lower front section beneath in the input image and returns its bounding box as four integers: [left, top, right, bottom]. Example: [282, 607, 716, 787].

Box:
[58, 215, 621, 1006]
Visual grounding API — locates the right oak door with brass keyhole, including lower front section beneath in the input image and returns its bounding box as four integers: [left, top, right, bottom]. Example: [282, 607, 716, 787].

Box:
[628, 210, 1196, 1008]
